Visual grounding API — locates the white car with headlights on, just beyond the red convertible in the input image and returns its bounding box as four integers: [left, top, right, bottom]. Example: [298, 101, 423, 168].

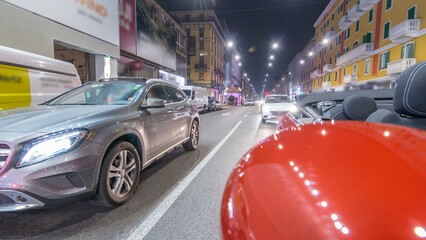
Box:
[261, 94, 298, 122]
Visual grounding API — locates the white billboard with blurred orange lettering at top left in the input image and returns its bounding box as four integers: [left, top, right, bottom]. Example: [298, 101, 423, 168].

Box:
[3, 0, 120, 46]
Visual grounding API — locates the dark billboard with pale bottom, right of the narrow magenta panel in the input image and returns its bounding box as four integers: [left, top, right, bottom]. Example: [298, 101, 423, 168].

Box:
[136, 0, 176, 70]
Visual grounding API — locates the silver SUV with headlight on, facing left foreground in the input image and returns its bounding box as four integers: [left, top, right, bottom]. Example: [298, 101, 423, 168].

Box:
[0, 79, 200, 211]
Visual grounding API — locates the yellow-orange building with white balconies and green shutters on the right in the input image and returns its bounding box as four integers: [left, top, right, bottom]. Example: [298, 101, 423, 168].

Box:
[311, 0, 426, 90]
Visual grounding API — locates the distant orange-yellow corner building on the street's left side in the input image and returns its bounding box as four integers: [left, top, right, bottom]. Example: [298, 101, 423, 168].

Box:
[172, 10, 226, 90]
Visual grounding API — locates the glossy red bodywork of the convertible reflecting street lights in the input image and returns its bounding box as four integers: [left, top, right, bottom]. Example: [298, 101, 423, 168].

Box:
[221, 121, 426, 239]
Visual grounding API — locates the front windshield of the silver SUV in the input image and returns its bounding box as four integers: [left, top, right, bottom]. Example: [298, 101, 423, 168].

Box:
[46, 81, 145, 105]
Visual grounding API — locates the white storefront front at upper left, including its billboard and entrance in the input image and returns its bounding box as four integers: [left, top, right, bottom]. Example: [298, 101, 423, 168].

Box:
[0, 0, 120, 83]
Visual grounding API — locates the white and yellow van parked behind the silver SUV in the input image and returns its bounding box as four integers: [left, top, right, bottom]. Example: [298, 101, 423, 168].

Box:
[0, 46, 81, 111]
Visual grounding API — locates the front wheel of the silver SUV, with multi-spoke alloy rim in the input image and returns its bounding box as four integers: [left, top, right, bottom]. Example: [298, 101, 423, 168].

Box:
[91, 142, 140, 207]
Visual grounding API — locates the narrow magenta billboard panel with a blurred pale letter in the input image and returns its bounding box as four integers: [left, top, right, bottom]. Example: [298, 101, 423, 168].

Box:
[118, 0, 136, 54]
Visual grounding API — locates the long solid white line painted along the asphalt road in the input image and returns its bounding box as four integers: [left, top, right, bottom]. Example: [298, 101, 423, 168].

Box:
[127, 121, 242, 240]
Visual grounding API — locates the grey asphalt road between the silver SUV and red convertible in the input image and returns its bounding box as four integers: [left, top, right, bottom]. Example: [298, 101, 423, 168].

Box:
[0, 106, 276, 239]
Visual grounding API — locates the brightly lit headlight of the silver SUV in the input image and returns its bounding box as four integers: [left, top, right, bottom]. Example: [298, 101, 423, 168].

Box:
[16, 129, 89, 167]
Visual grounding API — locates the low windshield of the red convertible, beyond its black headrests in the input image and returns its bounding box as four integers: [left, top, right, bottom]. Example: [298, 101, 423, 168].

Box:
[296, 89, 395, 106]
